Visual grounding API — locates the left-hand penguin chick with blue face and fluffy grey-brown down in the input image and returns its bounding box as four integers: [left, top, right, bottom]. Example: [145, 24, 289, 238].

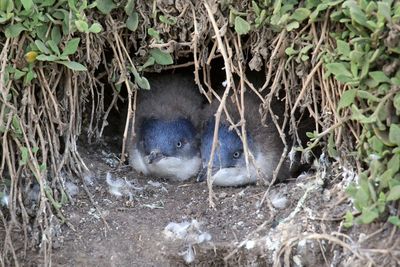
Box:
[128, 74, 202, 181]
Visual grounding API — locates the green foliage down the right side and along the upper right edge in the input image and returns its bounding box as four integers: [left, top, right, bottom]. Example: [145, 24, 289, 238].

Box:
[229, 0, 400, 225]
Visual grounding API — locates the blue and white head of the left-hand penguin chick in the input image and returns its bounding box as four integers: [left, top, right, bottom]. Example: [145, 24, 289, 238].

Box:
[138, 118, 201, 181]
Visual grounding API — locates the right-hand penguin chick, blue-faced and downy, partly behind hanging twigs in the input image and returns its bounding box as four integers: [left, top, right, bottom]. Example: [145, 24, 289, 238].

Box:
[198, 93, 288, 186]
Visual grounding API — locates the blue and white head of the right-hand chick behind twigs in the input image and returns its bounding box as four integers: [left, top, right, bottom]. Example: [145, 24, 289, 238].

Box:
[198, 119, 256, 186]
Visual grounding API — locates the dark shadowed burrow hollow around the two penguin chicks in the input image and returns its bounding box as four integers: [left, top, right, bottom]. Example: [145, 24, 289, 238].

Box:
[84, 54, 320, 183]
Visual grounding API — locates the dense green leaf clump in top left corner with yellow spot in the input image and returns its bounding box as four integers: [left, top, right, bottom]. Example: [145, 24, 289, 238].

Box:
[0, 0, 106, 84]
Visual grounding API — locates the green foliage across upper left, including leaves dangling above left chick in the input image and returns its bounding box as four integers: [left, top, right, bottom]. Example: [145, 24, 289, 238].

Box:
[0, 0, 177, 89]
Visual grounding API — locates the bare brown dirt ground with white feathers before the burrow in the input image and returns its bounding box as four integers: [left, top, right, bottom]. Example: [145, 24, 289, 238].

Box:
[11, 136, 394, 266]
